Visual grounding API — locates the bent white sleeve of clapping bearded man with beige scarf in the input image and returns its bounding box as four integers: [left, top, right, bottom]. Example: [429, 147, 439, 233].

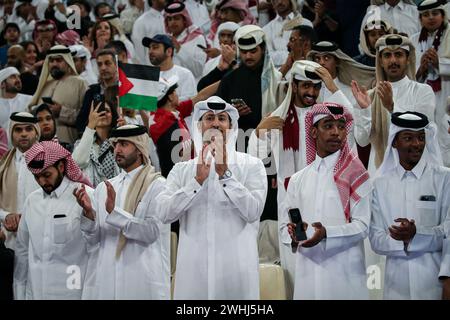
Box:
[106, 178, 164, 244]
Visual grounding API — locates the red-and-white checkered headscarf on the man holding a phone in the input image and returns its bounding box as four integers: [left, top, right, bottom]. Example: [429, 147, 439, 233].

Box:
[305, 102, 369, 222]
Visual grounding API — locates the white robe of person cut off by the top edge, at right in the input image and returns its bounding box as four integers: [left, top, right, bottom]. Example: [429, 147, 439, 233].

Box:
[361, 0, 420, 36]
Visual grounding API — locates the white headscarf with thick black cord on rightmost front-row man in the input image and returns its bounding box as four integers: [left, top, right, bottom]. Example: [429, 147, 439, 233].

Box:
[377, 111, 443, 176]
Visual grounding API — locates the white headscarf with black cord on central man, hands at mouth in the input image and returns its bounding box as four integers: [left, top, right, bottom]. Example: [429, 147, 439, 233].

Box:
[191, 96, 239, 160]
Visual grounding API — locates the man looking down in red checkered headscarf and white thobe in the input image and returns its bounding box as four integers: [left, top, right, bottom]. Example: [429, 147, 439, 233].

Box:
[14, 141, 93, 300]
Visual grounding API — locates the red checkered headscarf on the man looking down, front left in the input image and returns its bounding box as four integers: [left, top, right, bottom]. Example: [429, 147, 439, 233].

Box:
[25, 141, 92, 187]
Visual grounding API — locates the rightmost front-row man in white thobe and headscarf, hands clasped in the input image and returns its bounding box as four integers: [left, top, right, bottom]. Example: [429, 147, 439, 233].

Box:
[369, 112, 450, 300]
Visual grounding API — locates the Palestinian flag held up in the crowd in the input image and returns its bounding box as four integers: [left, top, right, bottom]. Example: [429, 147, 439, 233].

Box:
[119, 63, 159, 111]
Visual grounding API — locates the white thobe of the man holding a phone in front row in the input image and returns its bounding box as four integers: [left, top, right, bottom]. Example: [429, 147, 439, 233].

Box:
[283, 151, 370, 300]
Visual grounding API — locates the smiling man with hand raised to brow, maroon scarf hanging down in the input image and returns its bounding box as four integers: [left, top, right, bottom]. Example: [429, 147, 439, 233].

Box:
[249, 60, 352, 298]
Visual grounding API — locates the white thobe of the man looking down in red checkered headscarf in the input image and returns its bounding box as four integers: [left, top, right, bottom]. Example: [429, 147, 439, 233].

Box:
[14, 177, 88, 300]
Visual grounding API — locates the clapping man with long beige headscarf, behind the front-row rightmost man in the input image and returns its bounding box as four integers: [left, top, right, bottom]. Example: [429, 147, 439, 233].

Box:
[352, 34, 435, 172]
